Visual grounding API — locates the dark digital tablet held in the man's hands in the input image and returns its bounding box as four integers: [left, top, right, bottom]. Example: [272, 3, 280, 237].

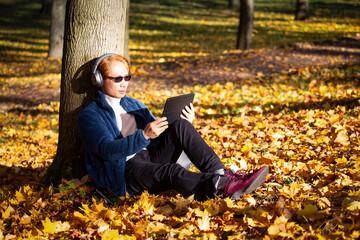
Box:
[162, 93, 195, 125]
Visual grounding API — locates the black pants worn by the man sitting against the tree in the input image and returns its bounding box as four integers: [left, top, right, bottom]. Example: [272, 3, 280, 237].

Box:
[125, 119, 225, 198]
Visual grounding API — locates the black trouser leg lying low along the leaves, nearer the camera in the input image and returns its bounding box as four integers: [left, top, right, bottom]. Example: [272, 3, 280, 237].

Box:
[125, 150, 216, 199]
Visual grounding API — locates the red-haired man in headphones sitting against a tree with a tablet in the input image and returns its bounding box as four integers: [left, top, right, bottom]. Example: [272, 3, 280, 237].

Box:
[78, 54, 269, 200]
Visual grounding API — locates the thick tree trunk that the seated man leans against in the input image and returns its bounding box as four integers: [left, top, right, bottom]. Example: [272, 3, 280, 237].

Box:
[41, 0, 127, 184]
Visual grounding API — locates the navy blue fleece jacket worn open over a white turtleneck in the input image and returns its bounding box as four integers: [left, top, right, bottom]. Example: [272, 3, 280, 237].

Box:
[78, 91, 155, 196]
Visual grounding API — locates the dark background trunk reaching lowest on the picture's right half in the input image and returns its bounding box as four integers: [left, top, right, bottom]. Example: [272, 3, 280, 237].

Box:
[236, 0, 254, 50]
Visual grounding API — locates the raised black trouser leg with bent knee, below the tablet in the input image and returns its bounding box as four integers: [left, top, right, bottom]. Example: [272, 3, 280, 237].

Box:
[149, 119, 225, 172]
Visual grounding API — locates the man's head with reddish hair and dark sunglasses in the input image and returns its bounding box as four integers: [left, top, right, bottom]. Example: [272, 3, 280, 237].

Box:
[93, 54, 131, 98]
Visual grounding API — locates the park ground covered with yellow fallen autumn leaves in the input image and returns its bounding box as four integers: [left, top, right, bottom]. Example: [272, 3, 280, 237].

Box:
[0, 0, 360, 239]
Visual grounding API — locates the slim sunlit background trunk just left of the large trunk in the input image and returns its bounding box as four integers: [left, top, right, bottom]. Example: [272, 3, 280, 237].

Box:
[48, 0, 66, 59]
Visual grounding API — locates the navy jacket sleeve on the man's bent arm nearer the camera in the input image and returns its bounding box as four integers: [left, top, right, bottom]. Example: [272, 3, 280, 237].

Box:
[78, 111, 150, 161]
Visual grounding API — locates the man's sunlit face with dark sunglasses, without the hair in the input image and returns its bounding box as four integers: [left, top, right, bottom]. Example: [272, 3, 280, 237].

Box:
[101, 61, 129, 98]
